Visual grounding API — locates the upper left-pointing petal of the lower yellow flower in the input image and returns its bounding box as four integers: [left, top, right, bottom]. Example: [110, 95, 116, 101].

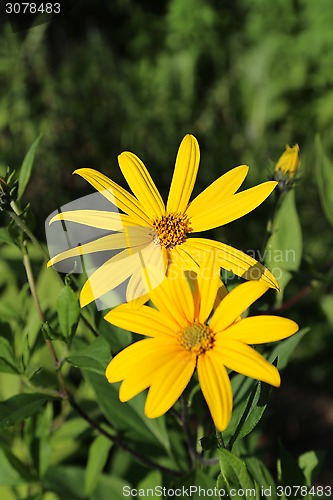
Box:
[104, 303, 178, 338]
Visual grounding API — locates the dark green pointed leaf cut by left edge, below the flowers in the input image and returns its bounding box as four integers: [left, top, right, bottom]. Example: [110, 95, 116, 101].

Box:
[0, 394, 50, 431]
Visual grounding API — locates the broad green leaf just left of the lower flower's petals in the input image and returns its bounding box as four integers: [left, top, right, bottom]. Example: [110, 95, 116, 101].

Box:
[67, 337, 112, 376]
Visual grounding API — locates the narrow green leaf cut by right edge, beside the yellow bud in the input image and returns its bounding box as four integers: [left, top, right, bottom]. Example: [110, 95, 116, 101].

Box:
[315, 135, 333, 226]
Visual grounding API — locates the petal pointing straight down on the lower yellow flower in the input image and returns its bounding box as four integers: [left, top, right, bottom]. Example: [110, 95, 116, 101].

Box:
[198, 349, 232, 431]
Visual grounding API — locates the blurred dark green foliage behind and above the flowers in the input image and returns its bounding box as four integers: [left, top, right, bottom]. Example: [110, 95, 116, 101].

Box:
[0, 0, 333, 492]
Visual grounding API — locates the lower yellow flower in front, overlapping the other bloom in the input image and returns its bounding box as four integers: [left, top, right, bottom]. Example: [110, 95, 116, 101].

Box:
[105, 251, 298, 431]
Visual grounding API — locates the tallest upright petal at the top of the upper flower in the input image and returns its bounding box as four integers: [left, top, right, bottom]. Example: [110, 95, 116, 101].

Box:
[167, 134, 200, 213]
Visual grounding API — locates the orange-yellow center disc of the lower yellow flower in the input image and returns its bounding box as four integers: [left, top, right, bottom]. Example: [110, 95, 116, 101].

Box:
[178, 323, 215, 356]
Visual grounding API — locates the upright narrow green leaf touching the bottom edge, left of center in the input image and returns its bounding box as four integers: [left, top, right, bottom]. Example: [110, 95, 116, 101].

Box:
[84, 435, 112, 496]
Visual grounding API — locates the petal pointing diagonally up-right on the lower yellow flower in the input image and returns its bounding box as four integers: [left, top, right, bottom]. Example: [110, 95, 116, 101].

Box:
[210, 281, 268, 332]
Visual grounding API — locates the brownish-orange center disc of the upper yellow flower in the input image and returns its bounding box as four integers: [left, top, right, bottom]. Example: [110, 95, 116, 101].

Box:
[152, 213, 193, 248]
